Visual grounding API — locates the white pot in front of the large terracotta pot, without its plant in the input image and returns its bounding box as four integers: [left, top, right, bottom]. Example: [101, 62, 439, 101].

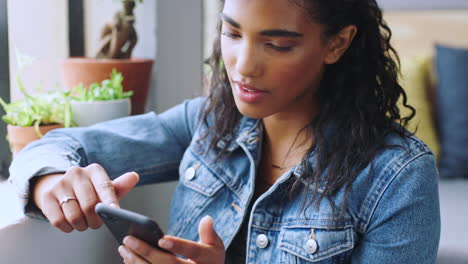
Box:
[71, 98, 131, 126]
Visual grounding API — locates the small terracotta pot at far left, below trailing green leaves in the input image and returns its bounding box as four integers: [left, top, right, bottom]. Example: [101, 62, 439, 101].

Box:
[7, 125, 63, 156]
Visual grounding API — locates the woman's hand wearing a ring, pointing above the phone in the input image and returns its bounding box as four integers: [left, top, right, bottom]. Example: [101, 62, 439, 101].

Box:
[33, 164, 139, 233]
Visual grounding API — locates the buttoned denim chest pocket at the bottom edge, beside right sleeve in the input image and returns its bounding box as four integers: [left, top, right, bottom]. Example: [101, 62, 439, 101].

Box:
[278, 225, 354, 264]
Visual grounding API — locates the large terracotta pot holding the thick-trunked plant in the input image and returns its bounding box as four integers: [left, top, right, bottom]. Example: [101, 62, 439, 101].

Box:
[62, 57, 154, 115]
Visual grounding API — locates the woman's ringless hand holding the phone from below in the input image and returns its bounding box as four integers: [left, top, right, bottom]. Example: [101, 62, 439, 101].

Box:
[119, 216, 225, 264]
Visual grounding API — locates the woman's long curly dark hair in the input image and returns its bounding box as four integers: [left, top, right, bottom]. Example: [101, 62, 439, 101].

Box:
[203, 0, 415, 216]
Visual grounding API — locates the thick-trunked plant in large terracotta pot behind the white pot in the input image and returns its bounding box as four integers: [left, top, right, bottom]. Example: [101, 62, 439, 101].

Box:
[62, 0, 153, 114]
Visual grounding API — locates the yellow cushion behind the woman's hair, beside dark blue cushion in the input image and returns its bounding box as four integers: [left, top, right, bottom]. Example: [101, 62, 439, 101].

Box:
[400, 56, 440, 160]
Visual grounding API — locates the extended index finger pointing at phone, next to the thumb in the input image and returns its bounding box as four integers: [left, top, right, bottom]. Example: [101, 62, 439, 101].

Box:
[85, 164, 119, 206]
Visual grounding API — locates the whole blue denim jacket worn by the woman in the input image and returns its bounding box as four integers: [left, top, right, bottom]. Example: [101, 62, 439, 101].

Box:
[10, 98, 440, 264]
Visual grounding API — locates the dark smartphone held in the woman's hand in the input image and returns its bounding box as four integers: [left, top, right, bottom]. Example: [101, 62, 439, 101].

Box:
[95, 203, 168, 252]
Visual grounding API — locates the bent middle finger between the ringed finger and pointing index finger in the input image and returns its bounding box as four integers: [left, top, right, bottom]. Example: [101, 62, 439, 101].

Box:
[74, 179, 102, 229]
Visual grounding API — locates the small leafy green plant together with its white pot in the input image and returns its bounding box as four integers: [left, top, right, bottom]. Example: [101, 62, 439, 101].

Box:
[66, 69, 133, 126]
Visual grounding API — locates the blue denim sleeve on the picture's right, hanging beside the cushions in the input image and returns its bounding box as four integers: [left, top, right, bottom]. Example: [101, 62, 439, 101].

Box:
[352, 153, 440, 264]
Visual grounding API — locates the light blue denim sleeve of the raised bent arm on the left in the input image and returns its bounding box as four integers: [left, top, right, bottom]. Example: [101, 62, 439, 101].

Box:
[9, 98, 205, 216]
